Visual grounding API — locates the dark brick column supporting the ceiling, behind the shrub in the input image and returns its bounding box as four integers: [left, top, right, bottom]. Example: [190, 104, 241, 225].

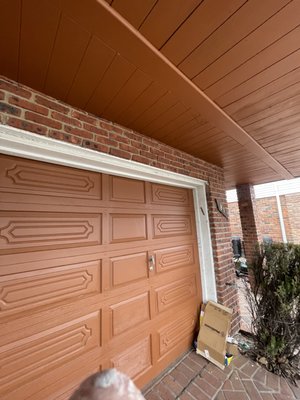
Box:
[236, 184, 260, 263]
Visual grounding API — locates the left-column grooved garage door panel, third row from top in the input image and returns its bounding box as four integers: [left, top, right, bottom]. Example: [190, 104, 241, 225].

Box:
[0, 261, 101, 316]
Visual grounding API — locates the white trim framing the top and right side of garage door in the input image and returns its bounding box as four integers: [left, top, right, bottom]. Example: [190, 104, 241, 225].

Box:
[0, 124, 217, 302]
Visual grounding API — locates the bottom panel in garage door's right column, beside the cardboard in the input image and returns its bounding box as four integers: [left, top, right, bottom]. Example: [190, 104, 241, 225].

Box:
[157, 309, 197, 360]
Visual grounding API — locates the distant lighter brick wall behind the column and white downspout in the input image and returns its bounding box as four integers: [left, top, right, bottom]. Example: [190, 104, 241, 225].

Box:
[228, 193, 300, 243]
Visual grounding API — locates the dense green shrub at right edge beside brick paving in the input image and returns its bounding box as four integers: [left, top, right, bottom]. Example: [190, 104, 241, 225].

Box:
[247, 243, 300, 381]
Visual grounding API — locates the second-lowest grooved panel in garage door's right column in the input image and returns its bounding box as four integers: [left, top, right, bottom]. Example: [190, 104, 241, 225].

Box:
[155, 275, 197, 313]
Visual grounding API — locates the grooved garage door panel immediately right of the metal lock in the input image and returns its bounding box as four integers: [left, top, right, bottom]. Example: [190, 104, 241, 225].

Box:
[154, 245, 195, 273]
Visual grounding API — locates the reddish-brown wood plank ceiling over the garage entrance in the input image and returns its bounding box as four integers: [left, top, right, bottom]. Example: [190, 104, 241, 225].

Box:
[0, 0, 300, 188]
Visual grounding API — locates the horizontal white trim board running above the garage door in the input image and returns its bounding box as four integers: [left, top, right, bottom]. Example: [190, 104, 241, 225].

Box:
[0, 124, 206, 188]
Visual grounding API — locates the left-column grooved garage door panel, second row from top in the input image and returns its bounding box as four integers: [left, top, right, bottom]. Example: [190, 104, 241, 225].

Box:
[0, 212, 101, 251]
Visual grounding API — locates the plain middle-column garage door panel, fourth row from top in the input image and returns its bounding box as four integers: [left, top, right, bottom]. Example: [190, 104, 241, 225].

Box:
[110, 292, 150, 336]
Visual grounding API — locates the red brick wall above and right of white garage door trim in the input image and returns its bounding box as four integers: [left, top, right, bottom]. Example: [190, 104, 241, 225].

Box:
[0, 77, 239, 330]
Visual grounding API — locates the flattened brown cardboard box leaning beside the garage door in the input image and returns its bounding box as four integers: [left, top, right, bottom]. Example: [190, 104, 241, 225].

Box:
[197, 301, 233, 369]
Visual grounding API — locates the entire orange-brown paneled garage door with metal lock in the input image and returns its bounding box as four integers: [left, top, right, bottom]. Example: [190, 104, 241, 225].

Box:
[0, 156, 201, 400]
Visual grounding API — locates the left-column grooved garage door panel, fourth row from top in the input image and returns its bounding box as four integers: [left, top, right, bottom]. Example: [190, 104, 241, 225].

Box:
[0, 312, 101, 392]
